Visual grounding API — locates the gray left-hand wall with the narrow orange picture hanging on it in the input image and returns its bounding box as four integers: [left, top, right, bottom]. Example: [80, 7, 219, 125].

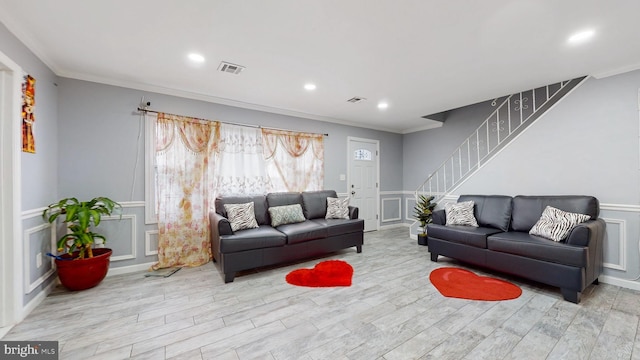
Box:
[0, 24, 58, 304]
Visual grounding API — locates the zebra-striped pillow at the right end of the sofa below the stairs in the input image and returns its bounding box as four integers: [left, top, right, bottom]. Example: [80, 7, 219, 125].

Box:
[529, 206, 591, 241]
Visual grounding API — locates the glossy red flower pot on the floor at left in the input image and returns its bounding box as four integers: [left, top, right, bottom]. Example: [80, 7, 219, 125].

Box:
[55, 248, 113, 291]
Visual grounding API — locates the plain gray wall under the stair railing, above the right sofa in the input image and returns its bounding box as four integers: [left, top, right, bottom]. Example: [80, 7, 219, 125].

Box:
[458, 71, 640, 205]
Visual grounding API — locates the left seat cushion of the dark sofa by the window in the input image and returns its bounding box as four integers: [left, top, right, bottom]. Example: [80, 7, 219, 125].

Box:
[220, 225, 287, 253]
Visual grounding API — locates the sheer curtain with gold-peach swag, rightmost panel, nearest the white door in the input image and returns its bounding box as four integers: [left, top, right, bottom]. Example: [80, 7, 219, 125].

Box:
[262, 129, 324, 191]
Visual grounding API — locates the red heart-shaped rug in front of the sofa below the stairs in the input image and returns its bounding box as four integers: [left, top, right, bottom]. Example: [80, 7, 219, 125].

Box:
[429, 267, 522, 301]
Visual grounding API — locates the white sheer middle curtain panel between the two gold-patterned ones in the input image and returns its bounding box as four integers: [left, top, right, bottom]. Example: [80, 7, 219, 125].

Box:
[213, 124, 271, 199]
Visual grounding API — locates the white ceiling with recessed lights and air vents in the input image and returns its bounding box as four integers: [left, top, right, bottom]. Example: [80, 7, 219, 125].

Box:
[0, 0, 640, 133]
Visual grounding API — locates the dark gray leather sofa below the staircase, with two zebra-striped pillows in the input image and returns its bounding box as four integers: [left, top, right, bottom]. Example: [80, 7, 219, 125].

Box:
[427, 195, 605, 303]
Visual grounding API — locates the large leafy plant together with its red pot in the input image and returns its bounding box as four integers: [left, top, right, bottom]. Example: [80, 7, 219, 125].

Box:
[42, 197, 122, 290]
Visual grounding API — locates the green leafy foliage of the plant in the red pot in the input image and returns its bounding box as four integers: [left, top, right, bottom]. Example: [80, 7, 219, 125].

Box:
[42, 197, 122, 259]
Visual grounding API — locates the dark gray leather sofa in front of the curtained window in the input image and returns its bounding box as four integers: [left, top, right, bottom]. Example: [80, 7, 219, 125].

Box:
[209, 190, 364, 283]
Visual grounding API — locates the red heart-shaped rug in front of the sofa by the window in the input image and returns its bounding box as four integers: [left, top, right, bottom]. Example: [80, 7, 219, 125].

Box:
[286, 260, 353, 287]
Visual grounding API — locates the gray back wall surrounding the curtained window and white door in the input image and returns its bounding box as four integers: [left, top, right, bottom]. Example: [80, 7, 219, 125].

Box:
[58, 78, 402, 269]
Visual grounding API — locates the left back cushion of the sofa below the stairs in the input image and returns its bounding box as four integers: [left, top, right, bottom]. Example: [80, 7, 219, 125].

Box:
[458, 195, 512, 231]
